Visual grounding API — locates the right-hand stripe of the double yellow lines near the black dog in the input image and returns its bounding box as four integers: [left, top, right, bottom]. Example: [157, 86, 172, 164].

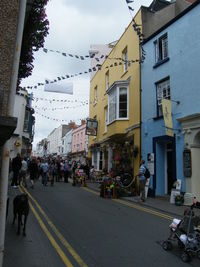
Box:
[22, 186, 88, 267]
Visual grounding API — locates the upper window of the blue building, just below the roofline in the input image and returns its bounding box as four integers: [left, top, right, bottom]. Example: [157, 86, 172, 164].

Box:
[155, 34, 168, 63]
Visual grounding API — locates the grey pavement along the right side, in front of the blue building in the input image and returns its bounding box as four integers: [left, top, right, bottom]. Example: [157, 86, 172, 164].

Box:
[84, 182, 194, 218]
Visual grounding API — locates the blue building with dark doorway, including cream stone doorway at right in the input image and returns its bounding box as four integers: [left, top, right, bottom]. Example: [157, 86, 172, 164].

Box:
[141, 0, 200, 201]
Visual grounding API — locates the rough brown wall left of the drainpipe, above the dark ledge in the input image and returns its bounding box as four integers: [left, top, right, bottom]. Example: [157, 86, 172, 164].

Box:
[0, 0, 20, 116]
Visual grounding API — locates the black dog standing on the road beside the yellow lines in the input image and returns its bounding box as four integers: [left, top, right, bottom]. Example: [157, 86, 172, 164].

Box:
[13, 194, 29, 236]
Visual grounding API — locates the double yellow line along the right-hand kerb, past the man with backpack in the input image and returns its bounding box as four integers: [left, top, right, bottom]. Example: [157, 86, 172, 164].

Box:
[83, 187, 174, 220]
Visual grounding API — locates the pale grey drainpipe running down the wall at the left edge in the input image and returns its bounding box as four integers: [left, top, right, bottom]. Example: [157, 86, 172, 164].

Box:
[0, 0, 27, 267]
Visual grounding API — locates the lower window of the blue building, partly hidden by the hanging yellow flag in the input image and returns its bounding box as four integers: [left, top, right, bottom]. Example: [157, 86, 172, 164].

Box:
[157, 79, 171, 117]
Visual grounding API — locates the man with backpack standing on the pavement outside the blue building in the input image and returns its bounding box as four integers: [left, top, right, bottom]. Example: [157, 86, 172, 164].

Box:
[135, 159, 150, 202]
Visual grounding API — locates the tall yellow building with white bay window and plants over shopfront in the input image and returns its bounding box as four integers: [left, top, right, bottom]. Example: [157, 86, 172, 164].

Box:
[89, 11, 141, 178]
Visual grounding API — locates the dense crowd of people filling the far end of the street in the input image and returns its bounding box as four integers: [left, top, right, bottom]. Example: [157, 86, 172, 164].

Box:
[10, 154, 90, 189]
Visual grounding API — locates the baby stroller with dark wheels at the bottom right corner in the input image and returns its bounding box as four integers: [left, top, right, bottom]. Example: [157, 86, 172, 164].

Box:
[162, 205, 200, 262]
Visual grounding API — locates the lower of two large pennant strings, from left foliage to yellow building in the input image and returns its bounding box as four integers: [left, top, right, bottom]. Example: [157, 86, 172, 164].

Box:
[23, 59, 142, 90]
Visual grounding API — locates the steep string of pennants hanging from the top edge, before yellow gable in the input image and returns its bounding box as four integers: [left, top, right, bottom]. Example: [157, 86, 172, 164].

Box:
[126, 0, 146, 63]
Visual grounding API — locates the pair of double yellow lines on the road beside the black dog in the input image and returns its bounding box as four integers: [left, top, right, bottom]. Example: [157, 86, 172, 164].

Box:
[20, 185, 88, 267]
